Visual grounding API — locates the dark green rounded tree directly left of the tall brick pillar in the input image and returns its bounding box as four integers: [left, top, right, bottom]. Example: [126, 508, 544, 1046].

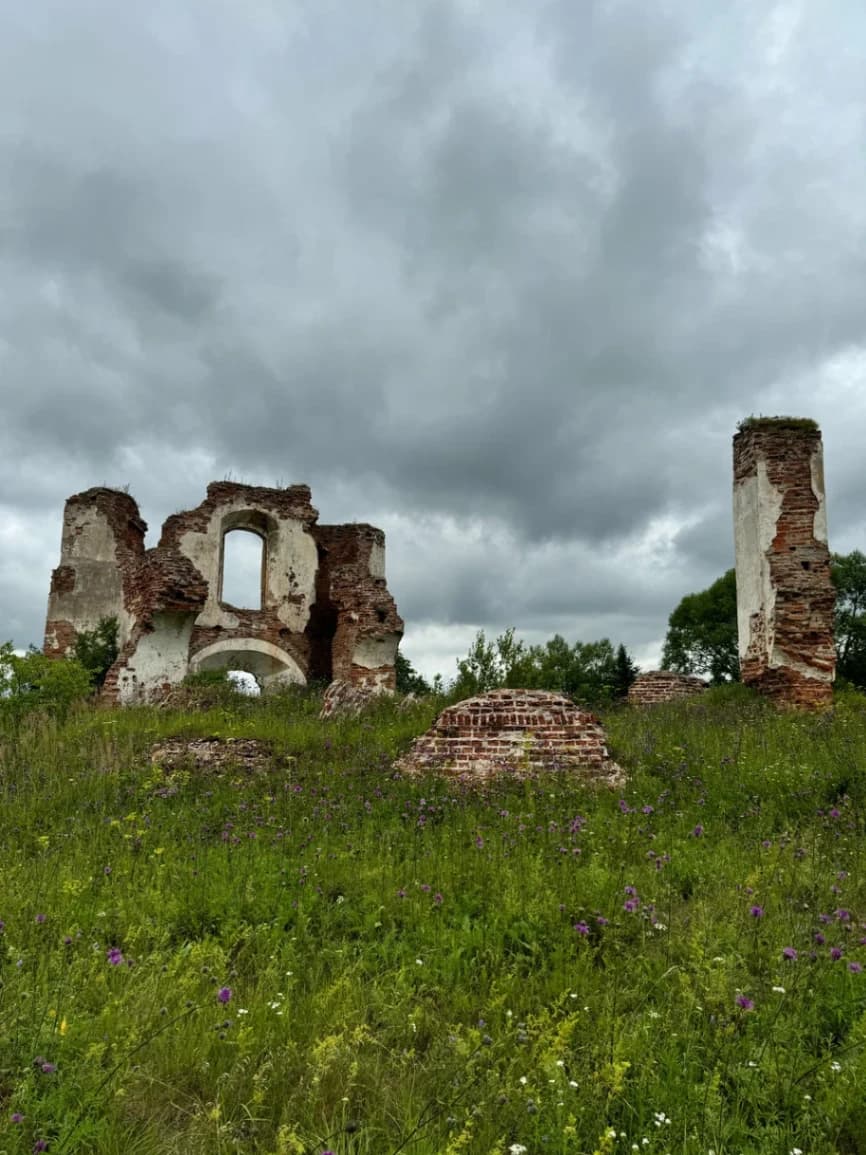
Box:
[662, 569, 740, 683]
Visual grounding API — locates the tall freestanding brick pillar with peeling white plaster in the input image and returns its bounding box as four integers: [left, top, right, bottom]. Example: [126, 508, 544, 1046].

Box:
[733, 417, 836, 708]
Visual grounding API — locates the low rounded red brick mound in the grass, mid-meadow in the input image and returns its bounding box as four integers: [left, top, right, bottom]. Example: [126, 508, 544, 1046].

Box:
[397, 690, 624, 785]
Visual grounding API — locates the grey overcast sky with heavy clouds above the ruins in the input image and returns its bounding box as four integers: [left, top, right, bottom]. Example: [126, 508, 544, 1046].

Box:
[0, 0, 866, 677]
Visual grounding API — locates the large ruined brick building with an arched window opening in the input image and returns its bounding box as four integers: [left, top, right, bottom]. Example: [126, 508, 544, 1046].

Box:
[44, 482, 403, 703]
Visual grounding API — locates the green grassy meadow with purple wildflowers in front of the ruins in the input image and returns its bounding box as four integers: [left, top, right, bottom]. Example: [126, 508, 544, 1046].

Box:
[0, 690, 866, 1155]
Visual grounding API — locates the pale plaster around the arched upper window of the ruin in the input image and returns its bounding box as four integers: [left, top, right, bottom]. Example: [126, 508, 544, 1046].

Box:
[180, 501, 319, 632]
